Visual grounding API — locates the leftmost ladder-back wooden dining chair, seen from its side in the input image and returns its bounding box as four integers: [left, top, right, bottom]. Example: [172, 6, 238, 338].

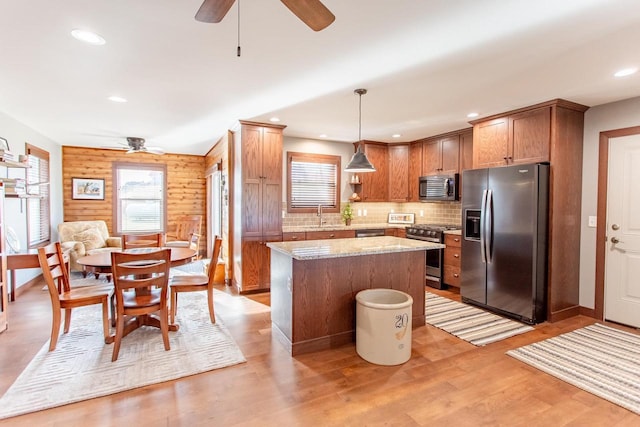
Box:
[38, 242, 113, 351]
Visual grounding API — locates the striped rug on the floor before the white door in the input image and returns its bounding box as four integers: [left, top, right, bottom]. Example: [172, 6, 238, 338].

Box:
[507, 323, 640, 414]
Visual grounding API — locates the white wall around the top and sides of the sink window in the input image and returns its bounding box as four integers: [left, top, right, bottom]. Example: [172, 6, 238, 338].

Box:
[282, 136, 354, 202]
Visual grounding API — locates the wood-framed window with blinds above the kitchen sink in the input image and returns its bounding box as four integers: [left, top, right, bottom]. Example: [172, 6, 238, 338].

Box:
[287, 152, 340, 213]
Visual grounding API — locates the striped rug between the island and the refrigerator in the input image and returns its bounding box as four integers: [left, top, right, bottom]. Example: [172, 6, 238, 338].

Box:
[425, 292, 533, 346]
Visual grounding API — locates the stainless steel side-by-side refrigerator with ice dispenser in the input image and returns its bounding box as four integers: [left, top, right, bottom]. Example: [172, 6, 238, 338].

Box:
[460, 163, 549, 323]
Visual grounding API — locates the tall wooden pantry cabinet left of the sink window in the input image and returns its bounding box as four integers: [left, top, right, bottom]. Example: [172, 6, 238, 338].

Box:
[230, 121, 284, 293]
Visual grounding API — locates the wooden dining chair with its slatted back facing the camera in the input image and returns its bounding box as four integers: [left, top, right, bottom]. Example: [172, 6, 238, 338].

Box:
[111, 248, 171, 362]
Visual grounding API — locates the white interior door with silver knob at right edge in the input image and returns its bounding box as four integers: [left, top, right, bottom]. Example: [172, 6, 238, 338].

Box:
[604, 135, 640, 327]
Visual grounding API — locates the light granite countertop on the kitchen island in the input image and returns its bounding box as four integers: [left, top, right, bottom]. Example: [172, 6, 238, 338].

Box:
[267, 236, 444, 260]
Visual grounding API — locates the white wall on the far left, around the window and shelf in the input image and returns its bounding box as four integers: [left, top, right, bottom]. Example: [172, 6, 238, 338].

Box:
[0, 112, 63, 286]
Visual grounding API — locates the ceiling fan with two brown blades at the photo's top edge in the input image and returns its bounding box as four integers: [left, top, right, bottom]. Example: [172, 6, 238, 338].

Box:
[196, 0, 336, 31]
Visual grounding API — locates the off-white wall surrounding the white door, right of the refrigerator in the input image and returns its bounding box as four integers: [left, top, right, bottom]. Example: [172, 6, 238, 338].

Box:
[580, 97, 640, 308]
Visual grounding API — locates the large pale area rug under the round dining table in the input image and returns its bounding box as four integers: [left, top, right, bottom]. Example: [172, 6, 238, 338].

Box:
[0, 292, 246, 419]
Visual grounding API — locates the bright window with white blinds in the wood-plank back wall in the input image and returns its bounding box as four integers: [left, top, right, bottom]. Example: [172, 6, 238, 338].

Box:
[113, 163, 167, 233]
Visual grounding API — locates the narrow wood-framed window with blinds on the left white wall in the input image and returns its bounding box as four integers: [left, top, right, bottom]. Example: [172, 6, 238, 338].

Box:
[25, 144, 51, 248]
